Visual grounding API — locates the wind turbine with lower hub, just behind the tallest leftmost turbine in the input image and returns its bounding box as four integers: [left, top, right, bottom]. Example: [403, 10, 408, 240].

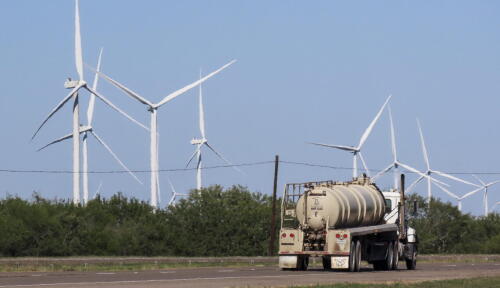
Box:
[38, 49, 145, 204]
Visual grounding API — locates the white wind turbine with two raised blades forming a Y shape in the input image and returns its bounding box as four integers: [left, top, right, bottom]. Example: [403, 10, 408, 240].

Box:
[92, 60, 236, 209]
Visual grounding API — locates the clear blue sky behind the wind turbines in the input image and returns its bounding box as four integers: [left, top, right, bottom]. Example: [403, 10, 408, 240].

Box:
[0, 0, 500, 215]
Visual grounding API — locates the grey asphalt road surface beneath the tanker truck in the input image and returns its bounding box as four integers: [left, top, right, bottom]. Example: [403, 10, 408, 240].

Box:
[0, 263, 500, 288]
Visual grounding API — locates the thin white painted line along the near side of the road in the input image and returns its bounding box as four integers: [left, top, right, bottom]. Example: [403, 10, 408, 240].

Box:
[0, 273, 325, 288]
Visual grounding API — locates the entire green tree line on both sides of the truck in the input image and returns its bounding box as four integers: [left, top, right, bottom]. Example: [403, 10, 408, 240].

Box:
[0, 186, 500, 257]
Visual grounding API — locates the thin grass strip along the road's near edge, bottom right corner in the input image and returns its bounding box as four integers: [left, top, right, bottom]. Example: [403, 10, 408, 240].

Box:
[293, 277, 500, 288]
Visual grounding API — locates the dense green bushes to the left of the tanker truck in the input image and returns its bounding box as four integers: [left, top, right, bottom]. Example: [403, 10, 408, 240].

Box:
[0, 186, 280, 256]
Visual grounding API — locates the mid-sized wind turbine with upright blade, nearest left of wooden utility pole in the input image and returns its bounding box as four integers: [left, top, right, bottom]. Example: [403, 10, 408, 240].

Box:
[186, 71, 241, 191]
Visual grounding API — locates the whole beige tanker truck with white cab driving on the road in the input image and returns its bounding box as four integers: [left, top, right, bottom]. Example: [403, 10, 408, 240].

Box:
[279, 175, 418, 272]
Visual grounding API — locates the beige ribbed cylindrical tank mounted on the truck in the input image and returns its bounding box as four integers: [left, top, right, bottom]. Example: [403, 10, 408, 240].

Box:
[296, 181, 385, 231]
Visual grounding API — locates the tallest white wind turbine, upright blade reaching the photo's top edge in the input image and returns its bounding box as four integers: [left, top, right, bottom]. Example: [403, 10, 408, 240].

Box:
[31, 0, 142, 204]
